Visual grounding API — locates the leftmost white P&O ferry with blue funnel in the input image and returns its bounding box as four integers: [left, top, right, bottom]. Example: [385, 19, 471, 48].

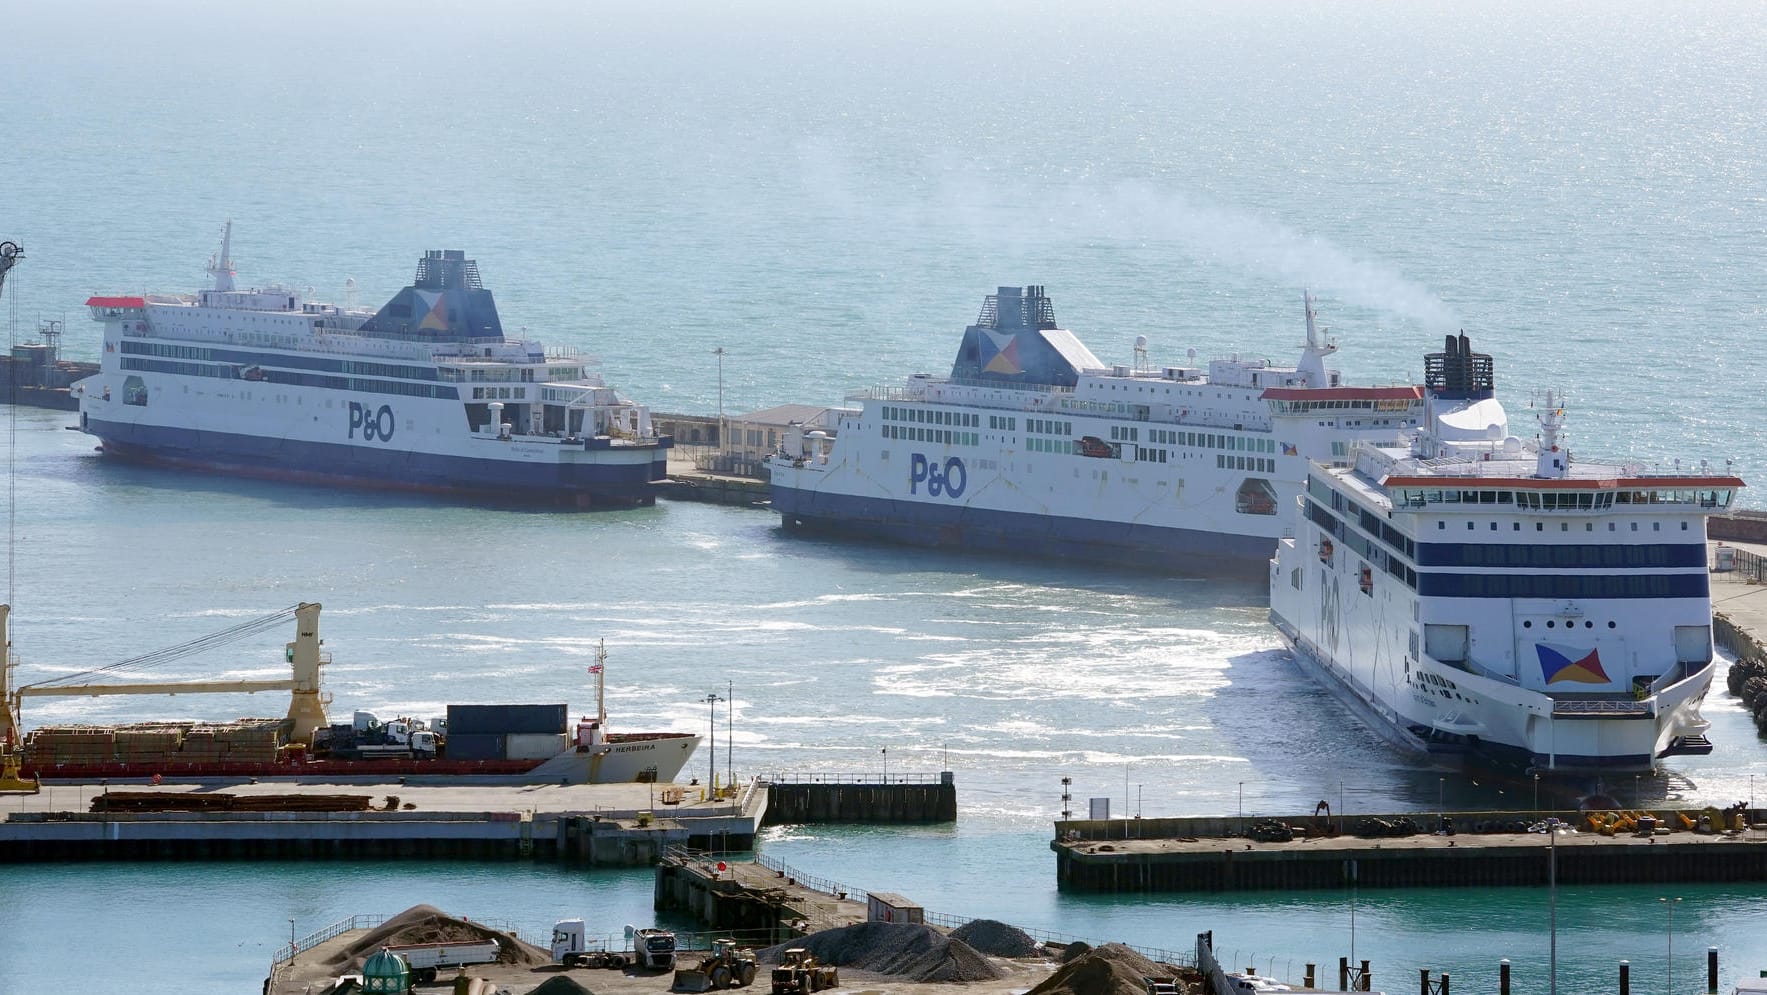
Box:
[74, 223, 670, 507]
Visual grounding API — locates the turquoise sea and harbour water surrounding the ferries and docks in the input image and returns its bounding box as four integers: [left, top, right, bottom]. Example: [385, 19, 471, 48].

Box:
[0, 0, 1767, 991]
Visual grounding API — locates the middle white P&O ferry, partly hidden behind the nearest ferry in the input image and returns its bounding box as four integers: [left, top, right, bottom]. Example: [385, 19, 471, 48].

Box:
[769, 286, 1422, 574]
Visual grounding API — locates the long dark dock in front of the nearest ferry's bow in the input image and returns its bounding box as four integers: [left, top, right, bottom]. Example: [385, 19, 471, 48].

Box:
[1050, 811, 1767, 892]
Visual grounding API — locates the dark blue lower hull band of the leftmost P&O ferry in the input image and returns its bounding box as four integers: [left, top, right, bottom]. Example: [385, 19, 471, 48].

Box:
[85, 419, 668, 507]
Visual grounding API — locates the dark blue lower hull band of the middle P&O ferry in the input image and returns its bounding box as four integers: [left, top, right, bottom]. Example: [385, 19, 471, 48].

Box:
[772, 484, 1276, 576]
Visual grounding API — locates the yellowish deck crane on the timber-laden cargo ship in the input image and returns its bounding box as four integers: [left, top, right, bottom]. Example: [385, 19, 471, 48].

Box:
[0, 603, 330, 744]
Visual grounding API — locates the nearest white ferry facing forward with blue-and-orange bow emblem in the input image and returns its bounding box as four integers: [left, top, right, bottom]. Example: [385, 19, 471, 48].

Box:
[1270, 336, 1742, 774]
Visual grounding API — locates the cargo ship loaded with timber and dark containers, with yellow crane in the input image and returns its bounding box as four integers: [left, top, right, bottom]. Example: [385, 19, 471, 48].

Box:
[0, 604, 700, 785]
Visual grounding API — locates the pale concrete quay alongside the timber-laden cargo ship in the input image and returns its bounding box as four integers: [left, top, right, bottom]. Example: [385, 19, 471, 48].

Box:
[0, 781, 767, 866]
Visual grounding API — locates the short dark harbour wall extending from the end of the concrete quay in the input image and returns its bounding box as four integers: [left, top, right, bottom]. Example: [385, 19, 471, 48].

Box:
[763, 771, 958, 825]
